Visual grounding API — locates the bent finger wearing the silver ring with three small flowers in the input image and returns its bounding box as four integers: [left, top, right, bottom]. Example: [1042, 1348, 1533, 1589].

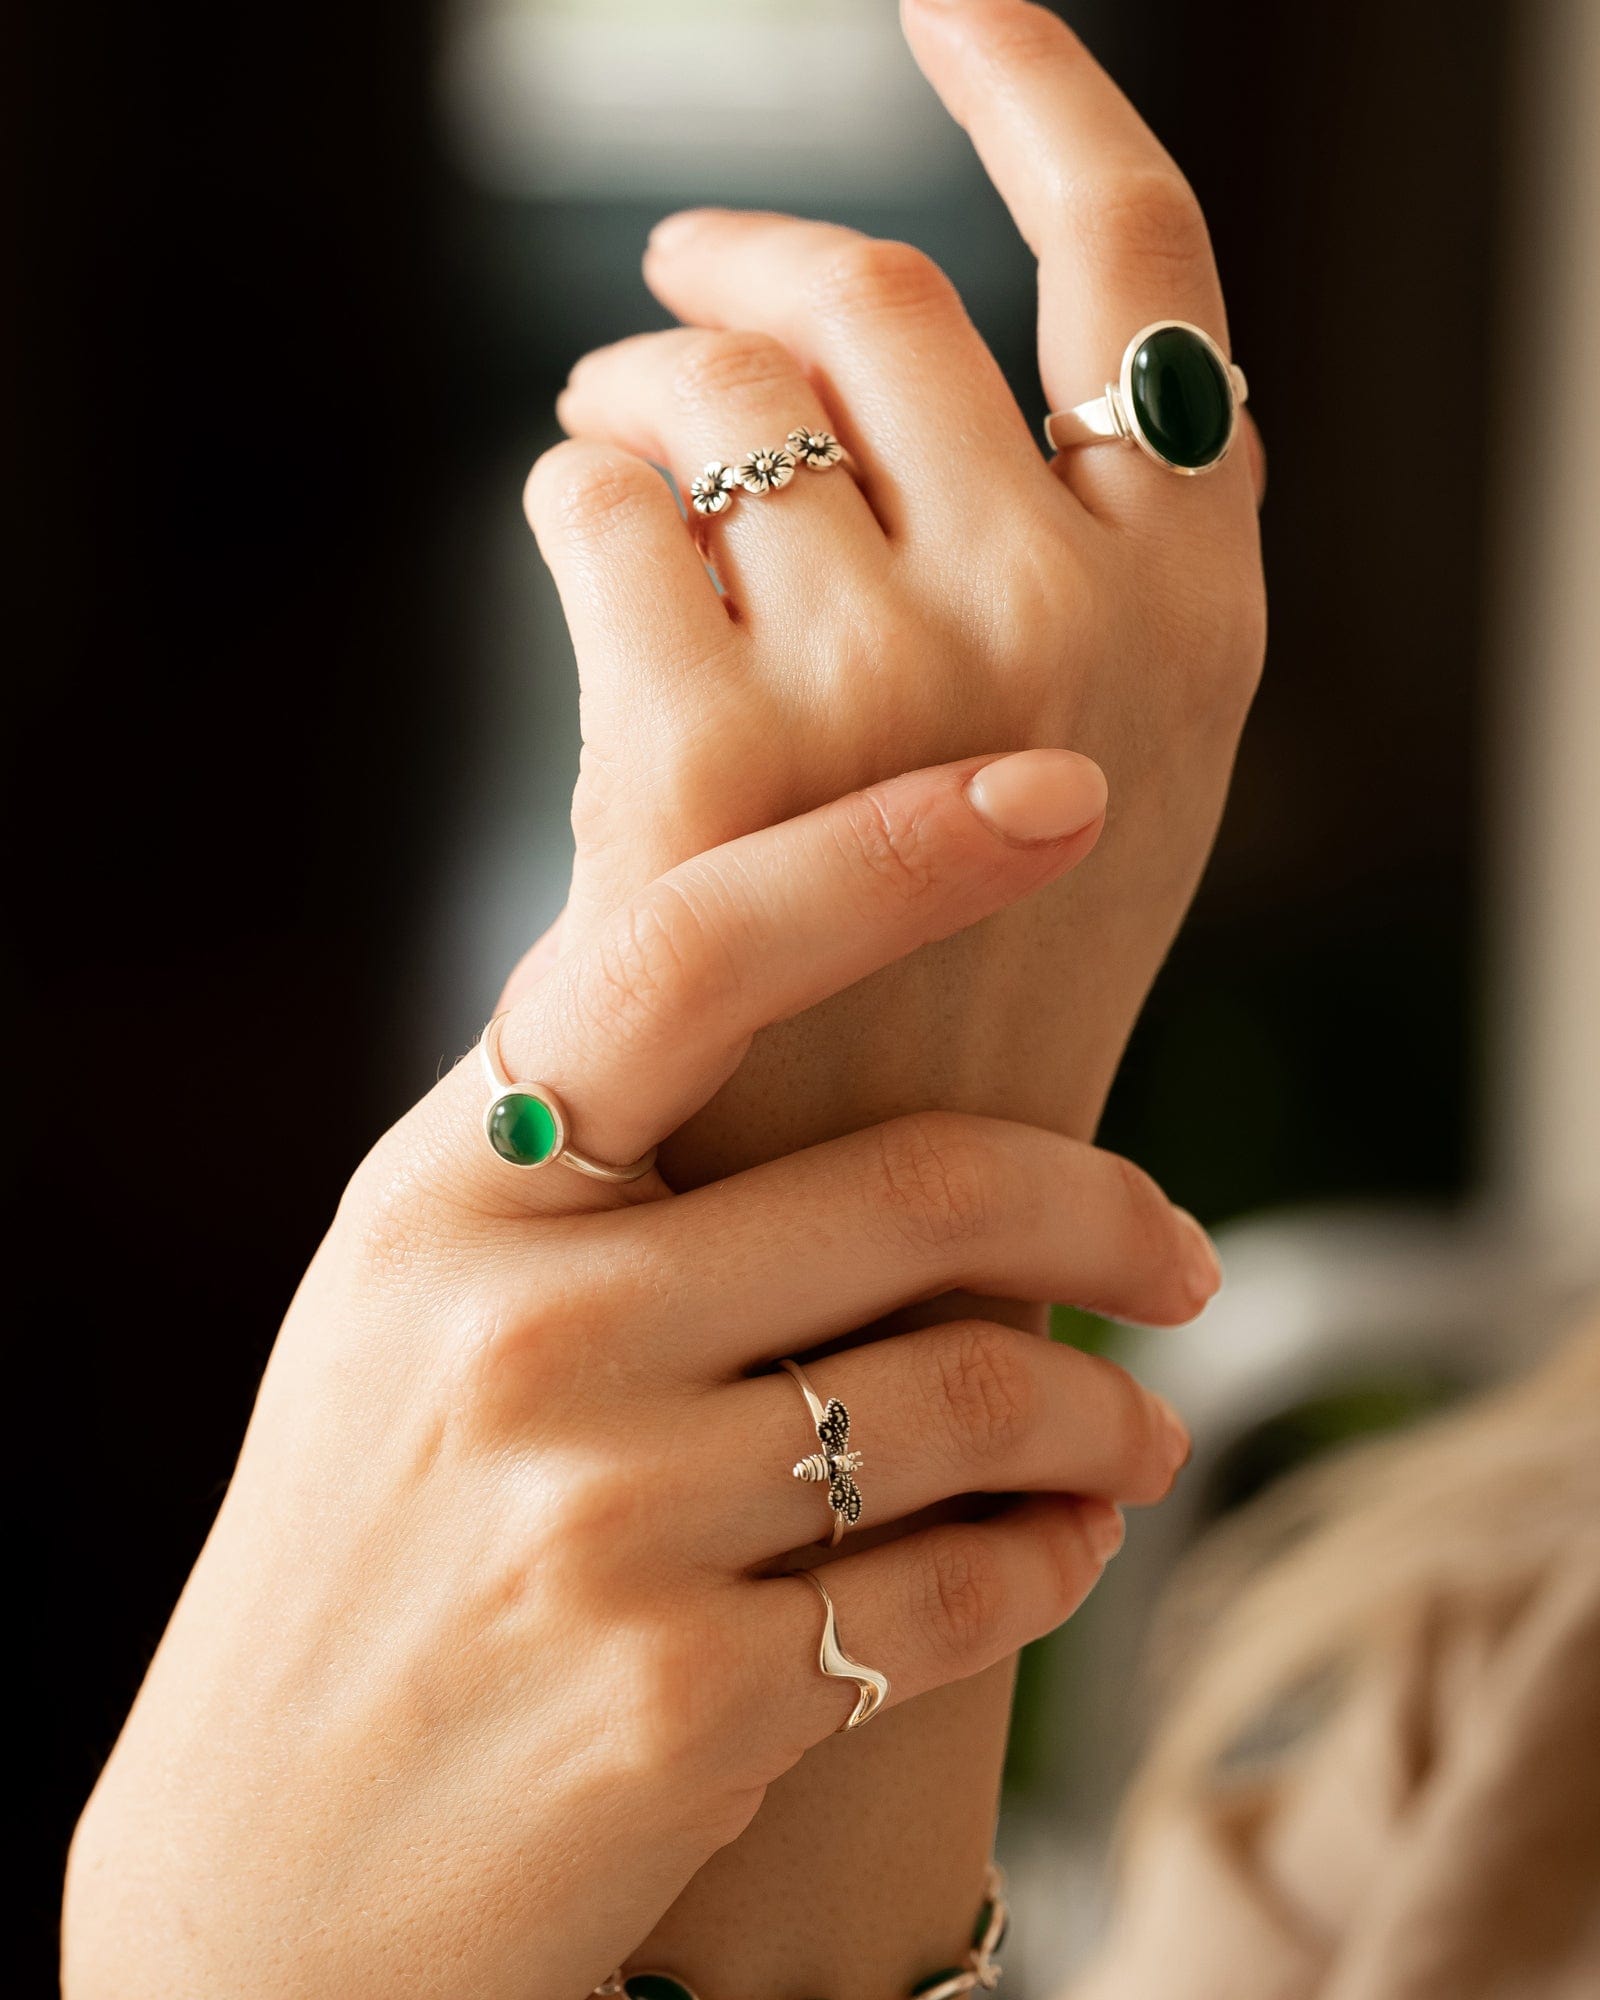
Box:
[556, 326, 882, 618]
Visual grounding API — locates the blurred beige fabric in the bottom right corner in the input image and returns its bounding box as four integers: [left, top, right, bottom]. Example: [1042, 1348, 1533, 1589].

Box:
[1070, 1522, 1600, 2000]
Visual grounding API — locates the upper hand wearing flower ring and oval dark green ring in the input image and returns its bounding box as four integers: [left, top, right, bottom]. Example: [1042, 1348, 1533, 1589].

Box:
[526, 0, 1264, 1184]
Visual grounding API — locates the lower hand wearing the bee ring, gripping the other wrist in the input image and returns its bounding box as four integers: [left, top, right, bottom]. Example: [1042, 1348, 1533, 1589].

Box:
[66, 752, 1214, 2000]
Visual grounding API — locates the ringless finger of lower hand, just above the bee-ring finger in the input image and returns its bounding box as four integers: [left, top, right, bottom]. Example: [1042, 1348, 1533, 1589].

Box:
[608, 1112, 1220, 1380]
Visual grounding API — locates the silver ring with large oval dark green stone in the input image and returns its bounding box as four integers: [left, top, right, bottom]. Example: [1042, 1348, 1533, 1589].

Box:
[1044, 320, 1250, 478]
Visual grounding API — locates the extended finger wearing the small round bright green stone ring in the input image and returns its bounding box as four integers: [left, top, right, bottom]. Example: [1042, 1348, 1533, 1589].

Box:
[410, 750, 1106, 1214]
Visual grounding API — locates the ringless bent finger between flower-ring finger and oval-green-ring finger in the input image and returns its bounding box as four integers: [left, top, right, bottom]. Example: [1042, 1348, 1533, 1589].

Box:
[644, 208, 1042, 534]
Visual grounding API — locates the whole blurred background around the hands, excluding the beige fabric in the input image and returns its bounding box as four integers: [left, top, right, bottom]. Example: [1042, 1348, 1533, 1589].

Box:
[15, 0, 1600, 1996]
